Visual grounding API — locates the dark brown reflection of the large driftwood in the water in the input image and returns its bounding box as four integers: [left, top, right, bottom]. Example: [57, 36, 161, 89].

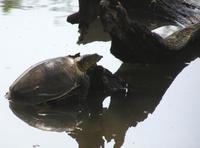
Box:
[104, 64, 186, 148]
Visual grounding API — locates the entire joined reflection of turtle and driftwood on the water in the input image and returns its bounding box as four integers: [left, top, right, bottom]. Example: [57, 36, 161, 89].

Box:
[10, 64, 186, 148]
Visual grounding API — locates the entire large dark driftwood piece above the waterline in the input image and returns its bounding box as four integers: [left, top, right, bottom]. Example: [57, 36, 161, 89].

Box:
[68, 0, 200, 64]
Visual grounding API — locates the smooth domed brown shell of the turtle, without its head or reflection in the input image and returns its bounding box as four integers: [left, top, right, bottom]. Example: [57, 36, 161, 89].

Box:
[8, 56, 84, 104]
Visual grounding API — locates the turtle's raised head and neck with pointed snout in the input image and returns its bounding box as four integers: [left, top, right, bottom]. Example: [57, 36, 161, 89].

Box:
[76, 54, 103, 72]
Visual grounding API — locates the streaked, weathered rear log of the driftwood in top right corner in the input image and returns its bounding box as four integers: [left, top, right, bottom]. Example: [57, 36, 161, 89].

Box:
[117, 0, 200, 28]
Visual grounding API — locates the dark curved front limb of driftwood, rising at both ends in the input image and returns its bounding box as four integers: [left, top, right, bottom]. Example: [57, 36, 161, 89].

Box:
[100, 3, 200, 64]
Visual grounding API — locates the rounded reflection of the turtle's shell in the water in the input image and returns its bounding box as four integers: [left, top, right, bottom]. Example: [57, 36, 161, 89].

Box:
[10, 100, 83, 132]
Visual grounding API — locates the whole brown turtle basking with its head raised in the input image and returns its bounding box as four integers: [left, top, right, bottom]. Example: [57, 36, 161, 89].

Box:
[6, 53, 102, 105]
